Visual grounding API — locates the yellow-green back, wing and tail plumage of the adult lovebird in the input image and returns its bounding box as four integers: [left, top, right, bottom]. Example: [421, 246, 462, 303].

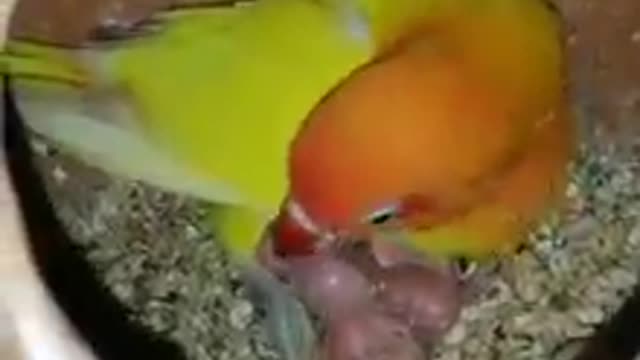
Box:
[0, 0, 375, 254]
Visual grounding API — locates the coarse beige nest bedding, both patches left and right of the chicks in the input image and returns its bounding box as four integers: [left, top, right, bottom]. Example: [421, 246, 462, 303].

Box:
[25, 127, 640, 360]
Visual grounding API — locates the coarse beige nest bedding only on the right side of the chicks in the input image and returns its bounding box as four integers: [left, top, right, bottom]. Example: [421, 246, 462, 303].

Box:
[437, 144, 640, 360]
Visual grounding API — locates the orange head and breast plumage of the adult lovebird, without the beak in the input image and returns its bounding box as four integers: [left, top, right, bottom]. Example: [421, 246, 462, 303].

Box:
[290, 0, 574, 256]
